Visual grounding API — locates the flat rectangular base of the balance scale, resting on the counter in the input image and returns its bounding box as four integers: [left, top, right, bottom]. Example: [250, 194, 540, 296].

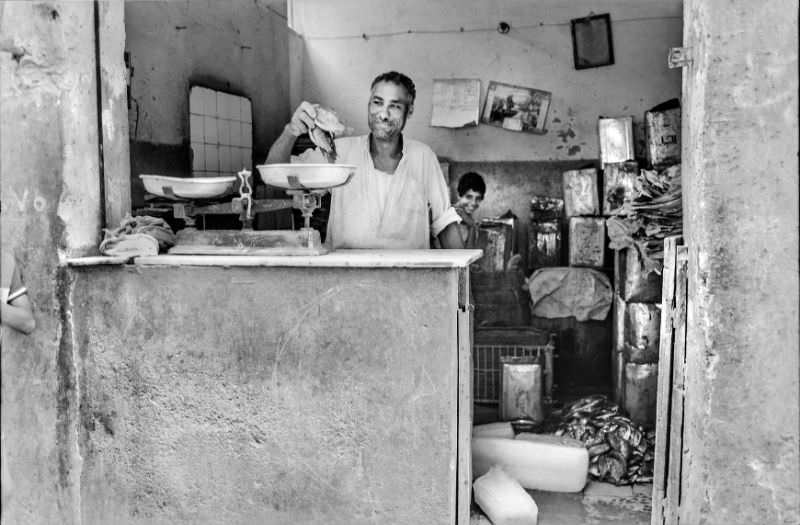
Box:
[167, 228, 329, 255]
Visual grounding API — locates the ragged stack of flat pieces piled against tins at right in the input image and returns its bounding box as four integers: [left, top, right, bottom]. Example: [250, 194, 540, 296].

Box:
[606, 164, 683, 273]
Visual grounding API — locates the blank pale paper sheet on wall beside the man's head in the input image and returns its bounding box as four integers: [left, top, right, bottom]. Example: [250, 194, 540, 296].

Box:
[431, 78, 481, 128]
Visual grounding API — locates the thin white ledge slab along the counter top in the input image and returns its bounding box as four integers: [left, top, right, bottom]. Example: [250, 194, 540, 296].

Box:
[67, 250, 482, 268]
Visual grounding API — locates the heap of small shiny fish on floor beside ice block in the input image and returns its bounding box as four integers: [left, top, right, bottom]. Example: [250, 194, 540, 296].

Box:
[550, 396, 655, 485]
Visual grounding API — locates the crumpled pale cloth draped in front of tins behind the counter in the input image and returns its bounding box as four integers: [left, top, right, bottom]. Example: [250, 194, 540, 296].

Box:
[524, 267, 613, 321]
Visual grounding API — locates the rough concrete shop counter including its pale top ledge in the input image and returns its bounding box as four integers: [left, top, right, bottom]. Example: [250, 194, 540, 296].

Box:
[62, 250, 480, 525]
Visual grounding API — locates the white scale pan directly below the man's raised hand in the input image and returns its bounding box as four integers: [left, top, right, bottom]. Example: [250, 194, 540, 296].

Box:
[256, 164, 356, 190]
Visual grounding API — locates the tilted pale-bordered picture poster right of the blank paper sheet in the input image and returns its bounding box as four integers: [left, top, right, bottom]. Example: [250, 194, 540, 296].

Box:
[481, 81, 552, 135]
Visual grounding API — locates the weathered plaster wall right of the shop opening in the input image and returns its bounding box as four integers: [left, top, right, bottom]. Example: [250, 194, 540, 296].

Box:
[681, 0, 800, 525]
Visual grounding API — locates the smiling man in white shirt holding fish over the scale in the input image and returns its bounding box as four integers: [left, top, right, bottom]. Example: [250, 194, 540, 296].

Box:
[266, 71, 464, 249]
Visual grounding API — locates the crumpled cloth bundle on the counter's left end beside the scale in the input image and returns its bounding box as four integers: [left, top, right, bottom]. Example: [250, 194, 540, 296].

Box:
[100, 211, 175, 257]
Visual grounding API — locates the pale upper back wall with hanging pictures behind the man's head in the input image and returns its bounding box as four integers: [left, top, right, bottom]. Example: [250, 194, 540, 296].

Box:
[290, 0, 682, 162]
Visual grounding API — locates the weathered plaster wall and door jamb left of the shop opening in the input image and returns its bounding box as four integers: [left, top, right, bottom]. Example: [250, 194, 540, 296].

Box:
[0, 2, 127, 525]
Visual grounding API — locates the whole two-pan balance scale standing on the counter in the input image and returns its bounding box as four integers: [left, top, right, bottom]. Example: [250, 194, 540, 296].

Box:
[140, 164, 356, 255]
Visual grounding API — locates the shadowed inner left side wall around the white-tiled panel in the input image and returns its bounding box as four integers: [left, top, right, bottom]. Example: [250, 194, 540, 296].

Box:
[125, 0, 292, 204]
